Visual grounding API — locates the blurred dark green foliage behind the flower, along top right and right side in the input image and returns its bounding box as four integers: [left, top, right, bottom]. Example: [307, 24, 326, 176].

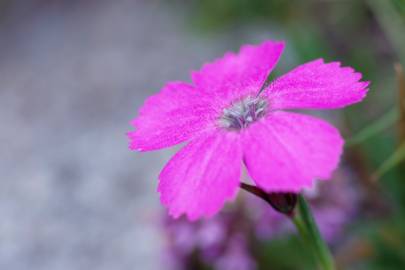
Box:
[176, 0, 405, 270]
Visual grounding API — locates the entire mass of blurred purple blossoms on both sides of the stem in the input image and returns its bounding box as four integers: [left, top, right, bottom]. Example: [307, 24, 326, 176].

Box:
[162, 167, 360, 270]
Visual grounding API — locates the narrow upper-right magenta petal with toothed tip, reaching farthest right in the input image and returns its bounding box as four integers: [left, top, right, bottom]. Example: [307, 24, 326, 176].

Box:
[266, 59, 369, 109]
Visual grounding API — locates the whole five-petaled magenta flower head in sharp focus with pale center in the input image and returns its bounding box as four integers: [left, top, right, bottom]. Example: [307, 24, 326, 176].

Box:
[128, 41, 368, 220]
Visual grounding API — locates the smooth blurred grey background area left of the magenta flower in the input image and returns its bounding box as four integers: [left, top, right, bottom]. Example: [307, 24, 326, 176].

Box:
[0, 0, 278, 270]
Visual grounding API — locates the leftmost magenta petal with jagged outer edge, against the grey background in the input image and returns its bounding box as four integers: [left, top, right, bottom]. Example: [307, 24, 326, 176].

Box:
[128, 82, 215, 151]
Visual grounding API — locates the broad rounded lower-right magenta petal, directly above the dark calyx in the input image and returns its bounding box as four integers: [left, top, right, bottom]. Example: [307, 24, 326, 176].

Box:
[242, 111, 343, 192]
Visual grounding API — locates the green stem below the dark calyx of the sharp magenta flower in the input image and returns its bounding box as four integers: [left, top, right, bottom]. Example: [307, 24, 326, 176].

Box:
[292, 195, 335, 270]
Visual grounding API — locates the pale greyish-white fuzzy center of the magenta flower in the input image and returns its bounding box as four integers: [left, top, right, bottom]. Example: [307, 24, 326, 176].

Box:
[219, 97, 267, 130]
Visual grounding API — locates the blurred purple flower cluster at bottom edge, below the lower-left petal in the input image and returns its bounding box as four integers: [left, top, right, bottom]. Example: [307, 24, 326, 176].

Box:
[162, 211, 256, 270]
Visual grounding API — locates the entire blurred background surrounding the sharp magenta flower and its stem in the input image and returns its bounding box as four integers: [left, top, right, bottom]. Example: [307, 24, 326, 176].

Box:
[0, 0, 405, 270]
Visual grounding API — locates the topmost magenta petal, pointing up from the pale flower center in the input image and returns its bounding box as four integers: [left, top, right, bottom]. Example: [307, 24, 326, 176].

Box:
[192, 41, 284, 101]
